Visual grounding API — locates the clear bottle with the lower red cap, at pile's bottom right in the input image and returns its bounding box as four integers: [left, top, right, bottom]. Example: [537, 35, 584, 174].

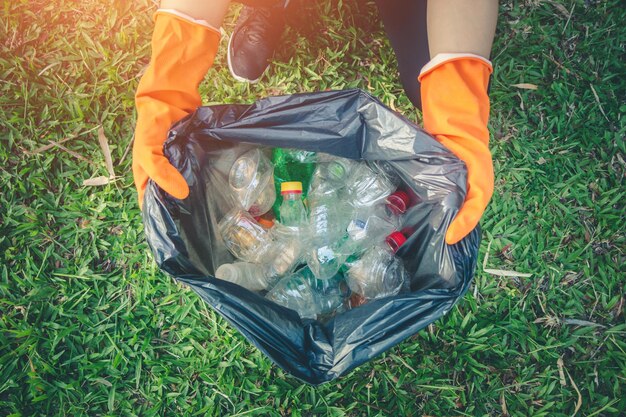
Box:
[345, 232, 410, 304]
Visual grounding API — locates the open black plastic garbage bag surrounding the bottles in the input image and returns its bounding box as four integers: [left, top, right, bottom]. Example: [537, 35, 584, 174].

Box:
[143, 90, 480, 384]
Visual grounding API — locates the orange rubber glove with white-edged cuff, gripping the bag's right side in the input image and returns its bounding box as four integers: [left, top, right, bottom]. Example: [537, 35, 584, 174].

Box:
[418, 54, 494, 245]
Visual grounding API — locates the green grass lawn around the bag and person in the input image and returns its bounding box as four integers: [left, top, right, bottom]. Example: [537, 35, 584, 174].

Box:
[0, 0, 626, 416]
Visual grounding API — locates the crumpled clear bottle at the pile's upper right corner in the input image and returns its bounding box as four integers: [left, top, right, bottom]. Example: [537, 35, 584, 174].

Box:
[347, 162, 400, 208]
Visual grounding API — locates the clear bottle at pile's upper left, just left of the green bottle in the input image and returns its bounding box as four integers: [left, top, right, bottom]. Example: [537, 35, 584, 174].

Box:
[228, 149, 276, 217]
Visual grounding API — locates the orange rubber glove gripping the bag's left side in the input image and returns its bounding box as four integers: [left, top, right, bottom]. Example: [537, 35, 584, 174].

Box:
[133, 10, 220, 207]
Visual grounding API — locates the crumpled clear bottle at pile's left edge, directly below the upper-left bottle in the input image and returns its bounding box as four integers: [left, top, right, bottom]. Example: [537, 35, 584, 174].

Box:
[217, 209, 272, 263]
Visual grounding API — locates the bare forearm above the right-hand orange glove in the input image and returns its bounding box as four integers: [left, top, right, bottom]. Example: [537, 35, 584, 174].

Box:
[427, 0, 498, 58]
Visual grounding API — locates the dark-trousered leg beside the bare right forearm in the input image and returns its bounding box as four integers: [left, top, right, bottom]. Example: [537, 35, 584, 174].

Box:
[376, 0, 430, 109]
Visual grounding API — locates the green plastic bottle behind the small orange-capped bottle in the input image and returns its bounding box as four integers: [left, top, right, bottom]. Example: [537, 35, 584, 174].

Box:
[272, 148, 315, 220]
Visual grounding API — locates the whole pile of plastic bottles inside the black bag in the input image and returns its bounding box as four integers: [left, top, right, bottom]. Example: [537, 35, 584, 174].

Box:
[215, 148, 409, 319]
